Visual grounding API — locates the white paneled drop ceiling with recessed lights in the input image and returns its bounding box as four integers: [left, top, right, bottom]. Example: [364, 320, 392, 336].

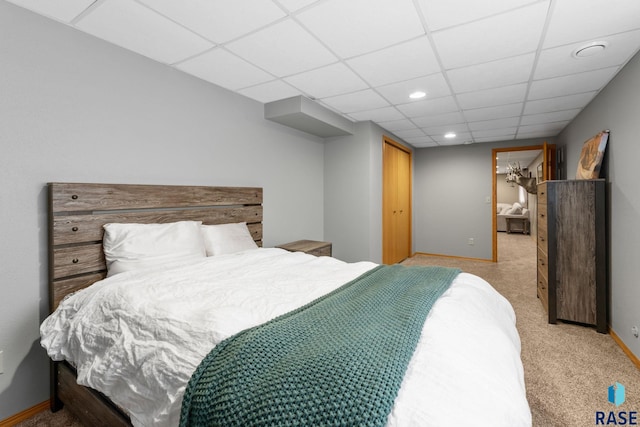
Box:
[9, 0, 640, 147]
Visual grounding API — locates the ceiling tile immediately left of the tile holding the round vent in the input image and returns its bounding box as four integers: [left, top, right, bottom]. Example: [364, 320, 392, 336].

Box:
[447, 53, 535, 93]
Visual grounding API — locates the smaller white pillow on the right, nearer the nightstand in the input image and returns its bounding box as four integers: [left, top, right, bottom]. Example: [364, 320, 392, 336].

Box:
[200, 222, 258, 256]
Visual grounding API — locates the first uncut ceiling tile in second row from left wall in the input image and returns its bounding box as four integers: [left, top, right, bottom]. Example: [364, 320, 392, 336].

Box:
[226, 19, 337, 77]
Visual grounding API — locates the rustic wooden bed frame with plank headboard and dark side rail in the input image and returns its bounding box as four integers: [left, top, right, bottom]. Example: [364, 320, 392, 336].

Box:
[48, 183, 262, 426]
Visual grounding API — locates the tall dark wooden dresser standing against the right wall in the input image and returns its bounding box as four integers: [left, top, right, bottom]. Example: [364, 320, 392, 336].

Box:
[537, 179, 607, 333]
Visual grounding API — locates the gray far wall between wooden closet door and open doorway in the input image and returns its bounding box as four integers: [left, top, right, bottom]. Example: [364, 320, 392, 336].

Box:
[413, 138, 552, 260]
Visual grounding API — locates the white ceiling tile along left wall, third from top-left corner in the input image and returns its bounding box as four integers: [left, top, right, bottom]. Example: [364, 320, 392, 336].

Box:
[176, 48, 273, 90]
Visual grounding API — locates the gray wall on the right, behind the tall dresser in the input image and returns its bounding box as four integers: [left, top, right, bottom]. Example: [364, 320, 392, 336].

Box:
[557, 54, 640, 358]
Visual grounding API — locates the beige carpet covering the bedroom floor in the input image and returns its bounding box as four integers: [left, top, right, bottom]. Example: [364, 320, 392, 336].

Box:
[15, 233, 640, 427]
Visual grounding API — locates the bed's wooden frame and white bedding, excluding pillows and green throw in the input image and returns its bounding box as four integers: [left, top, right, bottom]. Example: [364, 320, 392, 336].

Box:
[41, 183, 531, 426]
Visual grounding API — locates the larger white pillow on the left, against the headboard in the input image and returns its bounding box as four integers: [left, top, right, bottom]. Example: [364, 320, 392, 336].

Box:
[102, 221, 206, 276]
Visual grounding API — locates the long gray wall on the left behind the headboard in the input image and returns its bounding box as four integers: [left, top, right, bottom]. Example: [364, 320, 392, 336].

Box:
[0, 1, 324, 420]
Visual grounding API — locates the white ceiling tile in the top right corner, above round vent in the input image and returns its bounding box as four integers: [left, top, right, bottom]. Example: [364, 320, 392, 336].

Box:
[543, 0, 640, 48]
